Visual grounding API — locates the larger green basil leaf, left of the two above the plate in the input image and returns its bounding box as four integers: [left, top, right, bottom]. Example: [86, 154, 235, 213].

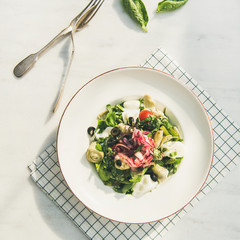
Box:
[122, 0, 148, 32]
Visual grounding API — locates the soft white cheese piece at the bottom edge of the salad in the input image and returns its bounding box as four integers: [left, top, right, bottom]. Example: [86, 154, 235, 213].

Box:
[132, 175, 158, 197]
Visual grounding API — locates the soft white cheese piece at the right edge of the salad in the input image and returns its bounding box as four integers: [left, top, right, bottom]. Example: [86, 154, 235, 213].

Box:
[161, 141, 184, 158]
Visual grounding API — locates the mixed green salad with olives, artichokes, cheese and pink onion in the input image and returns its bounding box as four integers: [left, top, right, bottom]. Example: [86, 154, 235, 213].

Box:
[86, 95, 184, 197]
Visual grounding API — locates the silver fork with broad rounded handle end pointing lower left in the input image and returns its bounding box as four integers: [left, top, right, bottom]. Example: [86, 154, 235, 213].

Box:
[13, 0, 104, 77]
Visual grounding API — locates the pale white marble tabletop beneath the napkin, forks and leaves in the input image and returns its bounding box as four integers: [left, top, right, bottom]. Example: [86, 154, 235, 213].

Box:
[0, 0, 240, 240]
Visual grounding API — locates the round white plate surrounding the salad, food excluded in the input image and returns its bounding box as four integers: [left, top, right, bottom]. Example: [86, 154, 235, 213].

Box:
[57, 67, 214, 223]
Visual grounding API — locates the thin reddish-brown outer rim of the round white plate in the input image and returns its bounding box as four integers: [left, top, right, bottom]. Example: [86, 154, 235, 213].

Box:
[56, 66, 215, 224]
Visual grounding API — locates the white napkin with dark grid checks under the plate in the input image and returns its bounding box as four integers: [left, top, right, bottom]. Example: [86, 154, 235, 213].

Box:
[29, 49, 240, 240]
